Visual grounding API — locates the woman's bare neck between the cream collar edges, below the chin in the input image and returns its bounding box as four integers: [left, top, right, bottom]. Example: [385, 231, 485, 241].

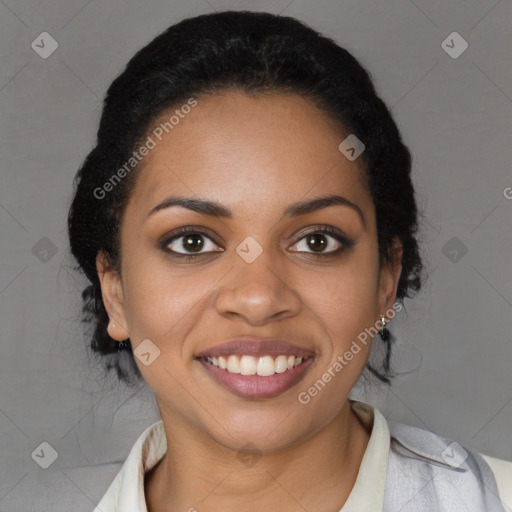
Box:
[145, 400, 370, 512]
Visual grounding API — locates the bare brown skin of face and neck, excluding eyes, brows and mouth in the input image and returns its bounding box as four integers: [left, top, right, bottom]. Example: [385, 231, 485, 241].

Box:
[97, 90, 401, 512]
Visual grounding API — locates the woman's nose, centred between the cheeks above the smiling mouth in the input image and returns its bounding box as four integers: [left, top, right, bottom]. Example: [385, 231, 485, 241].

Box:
[215, 251, 303, 326]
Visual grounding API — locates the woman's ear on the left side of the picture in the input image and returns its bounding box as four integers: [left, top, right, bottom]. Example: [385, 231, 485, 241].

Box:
[96, 251, 130, 341]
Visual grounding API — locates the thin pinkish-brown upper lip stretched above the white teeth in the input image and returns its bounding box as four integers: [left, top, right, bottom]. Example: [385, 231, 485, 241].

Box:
[196, 338, 315, 358]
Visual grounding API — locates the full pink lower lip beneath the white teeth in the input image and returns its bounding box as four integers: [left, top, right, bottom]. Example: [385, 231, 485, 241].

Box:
[198, 357, 314, 398]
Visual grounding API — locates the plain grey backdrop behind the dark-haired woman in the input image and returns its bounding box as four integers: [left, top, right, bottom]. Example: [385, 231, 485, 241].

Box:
[0, 0, 512, 512]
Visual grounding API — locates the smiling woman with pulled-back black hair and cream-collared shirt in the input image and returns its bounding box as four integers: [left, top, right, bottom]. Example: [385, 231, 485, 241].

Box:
[69, 12, 510, 512]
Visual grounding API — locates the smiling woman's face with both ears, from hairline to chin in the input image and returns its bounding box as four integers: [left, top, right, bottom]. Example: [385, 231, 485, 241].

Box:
[98, 91, 400, 451]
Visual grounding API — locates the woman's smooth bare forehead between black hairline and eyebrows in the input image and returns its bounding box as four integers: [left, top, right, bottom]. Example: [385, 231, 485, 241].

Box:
[125, 91, 371, 218]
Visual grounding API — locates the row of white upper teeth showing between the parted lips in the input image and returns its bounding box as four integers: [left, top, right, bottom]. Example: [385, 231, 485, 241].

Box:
[206, 354, 303, 377]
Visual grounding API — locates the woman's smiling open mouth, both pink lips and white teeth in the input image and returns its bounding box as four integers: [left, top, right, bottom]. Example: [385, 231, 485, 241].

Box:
[196, 340, 315, 398]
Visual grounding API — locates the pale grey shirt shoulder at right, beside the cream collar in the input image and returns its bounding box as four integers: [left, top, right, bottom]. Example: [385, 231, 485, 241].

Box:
[385, 422, 510, 512]
